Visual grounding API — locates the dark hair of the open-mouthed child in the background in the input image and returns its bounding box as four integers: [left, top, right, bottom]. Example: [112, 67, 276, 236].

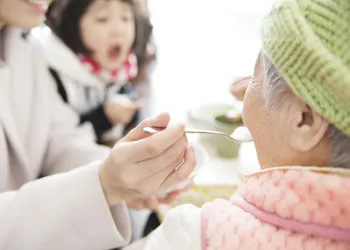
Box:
[46, 0, 137, 55]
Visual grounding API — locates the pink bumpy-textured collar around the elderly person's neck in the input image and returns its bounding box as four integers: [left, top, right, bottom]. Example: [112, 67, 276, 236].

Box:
[231, 168, 350, 243]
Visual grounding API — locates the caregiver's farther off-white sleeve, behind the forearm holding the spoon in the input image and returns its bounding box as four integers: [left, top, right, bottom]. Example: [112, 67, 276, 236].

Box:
[40, 75, 110, 176]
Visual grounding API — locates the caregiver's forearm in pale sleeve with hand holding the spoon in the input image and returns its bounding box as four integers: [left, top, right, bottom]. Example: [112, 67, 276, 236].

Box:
[0, 114, 195, 250]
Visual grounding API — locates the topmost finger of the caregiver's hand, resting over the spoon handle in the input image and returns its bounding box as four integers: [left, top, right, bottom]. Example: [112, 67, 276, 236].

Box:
[123, 113, 170, 142]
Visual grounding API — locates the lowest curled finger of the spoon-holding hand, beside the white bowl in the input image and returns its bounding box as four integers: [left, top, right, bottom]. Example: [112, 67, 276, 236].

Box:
[160, 148, 196, 190]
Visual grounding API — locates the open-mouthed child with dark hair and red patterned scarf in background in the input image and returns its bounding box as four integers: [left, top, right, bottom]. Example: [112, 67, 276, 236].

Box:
[36, 0, 152, 142]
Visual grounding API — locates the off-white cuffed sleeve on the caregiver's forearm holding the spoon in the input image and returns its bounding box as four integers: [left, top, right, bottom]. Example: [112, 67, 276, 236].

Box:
[0, 162, 131, 250]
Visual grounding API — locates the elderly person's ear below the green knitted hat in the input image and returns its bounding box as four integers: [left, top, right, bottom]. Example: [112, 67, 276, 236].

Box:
[287, 96, 329, 152]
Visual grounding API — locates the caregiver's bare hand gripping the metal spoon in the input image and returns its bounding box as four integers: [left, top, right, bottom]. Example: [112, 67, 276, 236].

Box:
[99, 114, 196, 206]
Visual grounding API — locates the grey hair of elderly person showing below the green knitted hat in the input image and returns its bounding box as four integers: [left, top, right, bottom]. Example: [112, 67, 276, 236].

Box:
[260, 52, 350, 168]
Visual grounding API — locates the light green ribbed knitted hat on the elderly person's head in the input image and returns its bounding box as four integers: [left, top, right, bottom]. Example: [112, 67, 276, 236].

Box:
[262, 0, 350, 135]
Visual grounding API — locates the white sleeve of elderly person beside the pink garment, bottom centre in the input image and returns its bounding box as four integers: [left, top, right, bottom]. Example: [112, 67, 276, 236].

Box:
[123, 205, 201, 250]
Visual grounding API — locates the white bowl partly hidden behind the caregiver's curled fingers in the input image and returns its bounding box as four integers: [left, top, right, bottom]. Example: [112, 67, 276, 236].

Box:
[157, 142, 209, 198]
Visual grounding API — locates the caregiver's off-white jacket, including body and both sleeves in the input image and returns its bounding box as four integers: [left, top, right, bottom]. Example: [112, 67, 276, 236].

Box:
[0, 28, 131, 250]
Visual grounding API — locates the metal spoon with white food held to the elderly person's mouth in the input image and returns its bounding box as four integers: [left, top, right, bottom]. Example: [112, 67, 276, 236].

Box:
[143, 127, 252, 142]
